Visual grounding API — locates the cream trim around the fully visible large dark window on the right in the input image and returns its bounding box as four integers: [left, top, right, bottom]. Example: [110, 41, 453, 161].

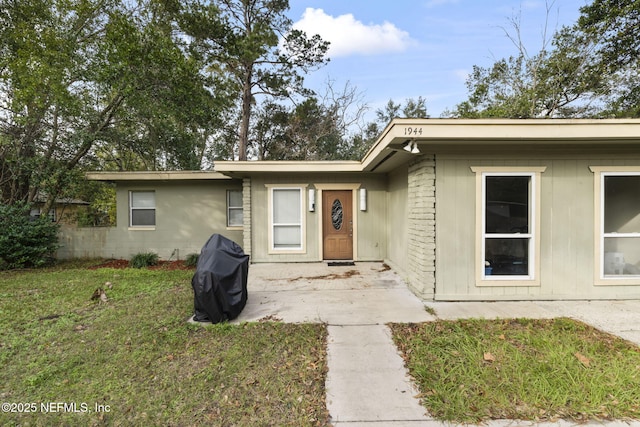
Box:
[471, 166, 547, 287]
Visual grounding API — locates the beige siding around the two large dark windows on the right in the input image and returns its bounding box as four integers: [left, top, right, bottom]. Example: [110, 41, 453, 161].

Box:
[436, 152, 640, 300]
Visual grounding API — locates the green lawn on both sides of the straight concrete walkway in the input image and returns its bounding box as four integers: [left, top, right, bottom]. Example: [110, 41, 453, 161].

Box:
[5, 263, 640, 426]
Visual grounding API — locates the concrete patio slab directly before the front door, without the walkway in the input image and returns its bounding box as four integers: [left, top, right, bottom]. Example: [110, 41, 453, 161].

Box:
[232, 263, 433, 326]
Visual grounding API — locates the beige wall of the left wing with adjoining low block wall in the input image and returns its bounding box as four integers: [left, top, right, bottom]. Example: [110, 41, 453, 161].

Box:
[59, 180, 243, 259]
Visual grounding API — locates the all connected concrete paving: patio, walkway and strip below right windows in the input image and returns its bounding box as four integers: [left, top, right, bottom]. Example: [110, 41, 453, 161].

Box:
[234, 263, 640, 427]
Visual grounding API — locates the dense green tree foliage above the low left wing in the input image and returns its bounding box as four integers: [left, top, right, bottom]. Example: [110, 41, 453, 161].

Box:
[0, 0, 230, 212]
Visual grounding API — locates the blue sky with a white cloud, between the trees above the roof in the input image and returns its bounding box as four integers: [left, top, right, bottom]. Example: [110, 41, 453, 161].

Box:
[289, 0, 589, 117]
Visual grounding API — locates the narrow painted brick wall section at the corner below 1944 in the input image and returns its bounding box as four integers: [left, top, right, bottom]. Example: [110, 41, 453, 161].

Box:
[407, 156, 436, 300]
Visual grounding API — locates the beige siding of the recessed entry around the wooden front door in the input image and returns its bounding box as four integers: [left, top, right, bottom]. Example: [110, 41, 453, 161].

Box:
[245, 174, 387, 262]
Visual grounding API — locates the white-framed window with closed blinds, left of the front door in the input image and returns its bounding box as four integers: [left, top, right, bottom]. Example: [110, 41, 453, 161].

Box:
[270, 187, 304, 251]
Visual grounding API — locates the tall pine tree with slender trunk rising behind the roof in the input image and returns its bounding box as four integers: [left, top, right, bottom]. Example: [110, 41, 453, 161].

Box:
[180, 0, 329, 160]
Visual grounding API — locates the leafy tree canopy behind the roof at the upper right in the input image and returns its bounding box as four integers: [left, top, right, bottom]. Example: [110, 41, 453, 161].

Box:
[445, 0, 640, 118]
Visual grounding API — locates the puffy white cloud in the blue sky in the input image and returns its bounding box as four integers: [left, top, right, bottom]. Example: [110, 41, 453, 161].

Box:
[293, 8, 415, 58]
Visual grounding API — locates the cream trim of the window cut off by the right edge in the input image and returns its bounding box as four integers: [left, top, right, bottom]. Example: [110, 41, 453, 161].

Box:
[589, 166, 640, 286]
